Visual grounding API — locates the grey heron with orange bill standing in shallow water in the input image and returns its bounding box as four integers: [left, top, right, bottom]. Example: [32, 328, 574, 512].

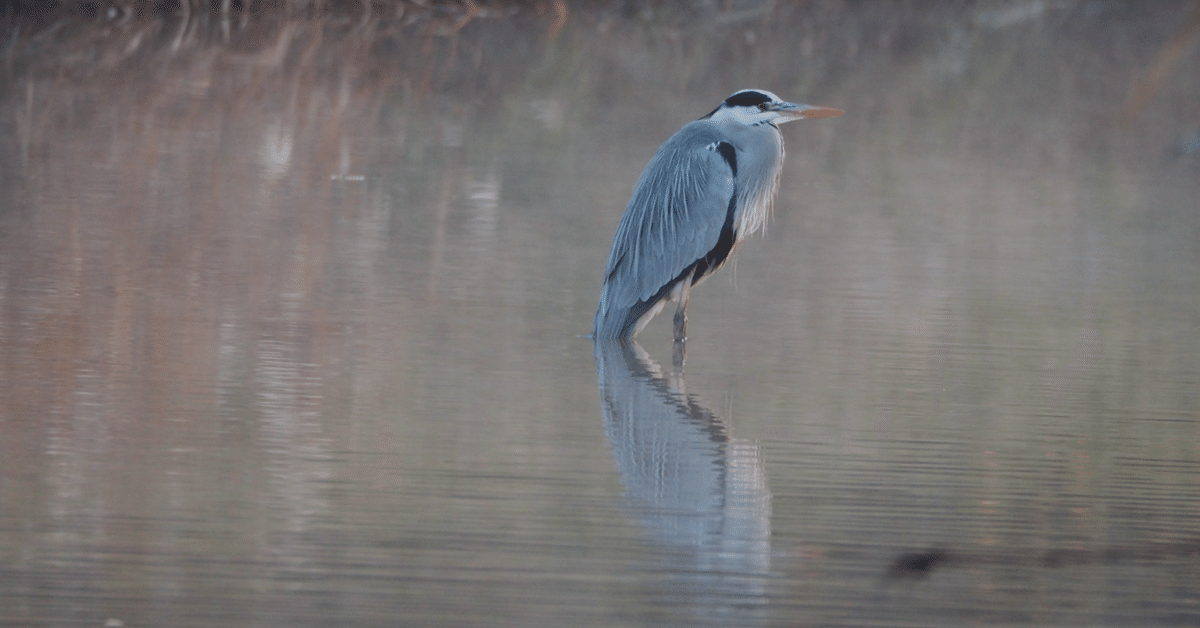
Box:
[593, 89, 842, 342]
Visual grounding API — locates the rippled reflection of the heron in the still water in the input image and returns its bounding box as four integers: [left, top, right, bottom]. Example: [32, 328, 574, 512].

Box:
[595, 340, 770, 626]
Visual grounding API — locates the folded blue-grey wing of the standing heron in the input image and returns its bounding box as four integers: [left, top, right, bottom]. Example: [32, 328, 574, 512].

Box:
[595, 121, 737, 337]
